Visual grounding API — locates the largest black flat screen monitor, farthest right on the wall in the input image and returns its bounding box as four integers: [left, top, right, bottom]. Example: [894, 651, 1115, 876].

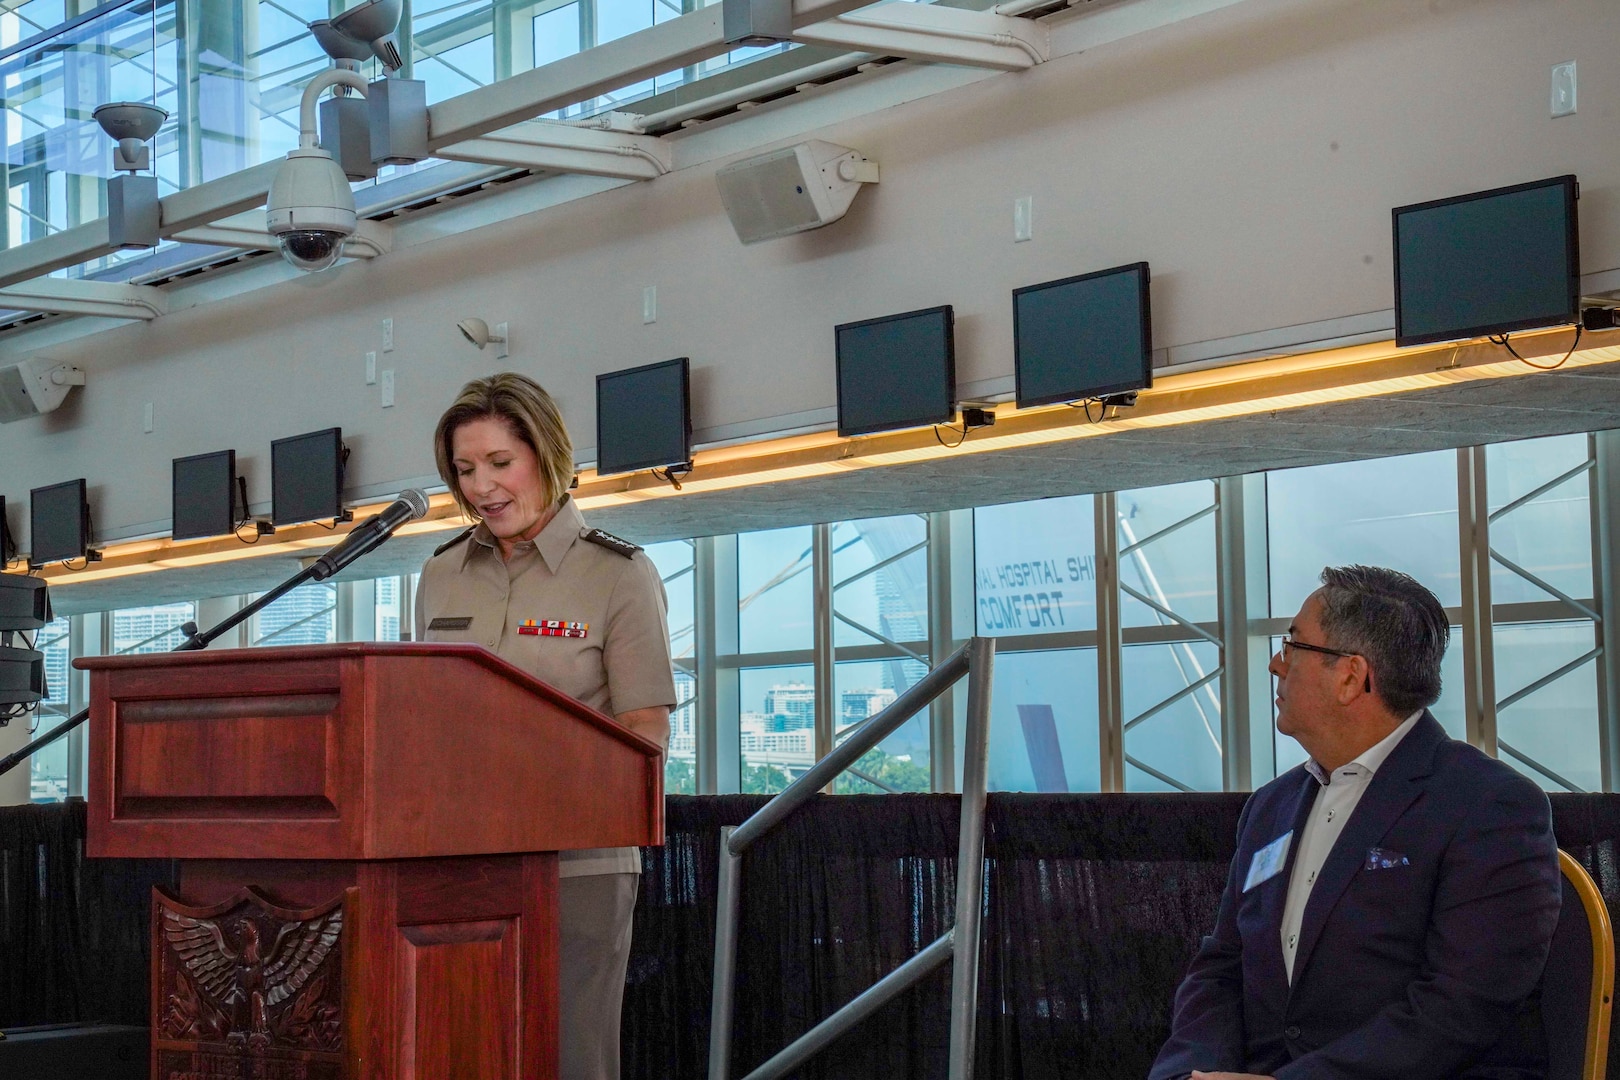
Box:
[1395, 176, 1581, 345]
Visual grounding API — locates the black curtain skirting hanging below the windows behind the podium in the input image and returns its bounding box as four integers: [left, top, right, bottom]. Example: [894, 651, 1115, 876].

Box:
[0, 795, 1620, 1080]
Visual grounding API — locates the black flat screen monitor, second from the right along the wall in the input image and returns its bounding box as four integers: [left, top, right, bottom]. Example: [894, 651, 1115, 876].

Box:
[1013, 262, 1153, 408]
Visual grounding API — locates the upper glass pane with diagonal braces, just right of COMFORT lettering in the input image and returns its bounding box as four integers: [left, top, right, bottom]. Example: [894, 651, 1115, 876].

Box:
[1116, 479, 1218, 627]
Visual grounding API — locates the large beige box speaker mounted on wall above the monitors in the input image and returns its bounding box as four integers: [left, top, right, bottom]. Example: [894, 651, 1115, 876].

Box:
[714, 139, 878, 244]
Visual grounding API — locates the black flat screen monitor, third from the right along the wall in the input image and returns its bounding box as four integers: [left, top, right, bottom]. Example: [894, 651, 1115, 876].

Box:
[834, 304, 956, 436]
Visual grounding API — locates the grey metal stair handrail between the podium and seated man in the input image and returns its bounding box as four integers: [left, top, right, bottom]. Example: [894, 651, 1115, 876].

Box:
[708, 638, 996, 1080]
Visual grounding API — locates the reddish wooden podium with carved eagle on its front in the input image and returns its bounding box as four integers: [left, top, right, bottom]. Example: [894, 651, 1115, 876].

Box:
[76, 643, 664, 1080]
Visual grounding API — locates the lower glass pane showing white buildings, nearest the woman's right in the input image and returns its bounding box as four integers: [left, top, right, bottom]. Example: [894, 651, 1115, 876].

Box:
[737, 664, 815, 795]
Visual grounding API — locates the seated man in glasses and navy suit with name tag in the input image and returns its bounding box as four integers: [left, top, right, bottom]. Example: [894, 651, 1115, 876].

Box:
[1150, 567, 1560, 1080]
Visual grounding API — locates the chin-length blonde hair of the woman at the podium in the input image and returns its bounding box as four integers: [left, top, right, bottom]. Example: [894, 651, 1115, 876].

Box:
[433, 371, 573, 521]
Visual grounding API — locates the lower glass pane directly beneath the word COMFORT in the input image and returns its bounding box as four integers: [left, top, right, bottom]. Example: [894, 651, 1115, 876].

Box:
[988, 649, 1102, 792]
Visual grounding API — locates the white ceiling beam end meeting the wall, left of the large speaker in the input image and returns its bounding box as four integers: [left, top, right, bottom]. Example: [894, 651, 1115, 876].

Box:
[434, 120, 674, 180]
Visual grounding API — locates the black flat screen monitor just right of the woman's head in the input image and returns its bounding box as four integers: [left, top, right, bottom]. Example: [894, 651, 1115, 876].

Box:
[596, 356, 692, 474]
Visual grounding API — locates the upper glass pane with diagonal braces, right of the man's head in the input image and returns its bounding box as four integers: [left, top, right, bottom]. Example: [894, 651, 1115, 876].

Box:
[1486, 436, 1592, 604]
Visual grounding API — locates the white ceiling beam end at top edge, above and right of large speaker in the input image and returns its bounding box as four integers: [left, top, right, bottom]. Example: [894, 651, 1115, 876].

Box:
[794, 3, 1051, 71]
